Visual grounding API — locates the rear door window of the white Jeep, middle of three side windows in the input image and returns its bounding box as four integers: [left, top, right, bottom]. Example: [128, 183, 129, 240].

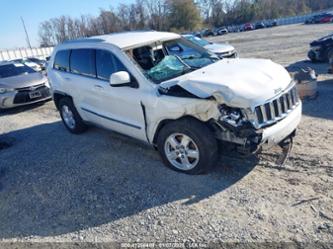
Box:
[70, 49, 96, 77]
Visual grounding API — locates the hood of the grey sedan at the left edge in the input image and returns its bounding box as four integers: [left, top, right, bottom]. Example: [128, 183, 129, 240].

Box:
[0, 72, 47, 89]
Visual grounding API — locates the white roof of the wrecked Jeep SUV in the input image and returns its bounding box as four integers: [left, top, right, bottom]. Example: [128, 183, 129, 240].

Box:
[81, 31, 181, 49]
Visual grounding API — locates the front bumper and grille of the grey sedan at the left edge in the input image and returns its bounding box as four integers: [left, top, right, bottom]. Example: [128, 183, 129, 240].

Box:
[0, 86, 51, 109]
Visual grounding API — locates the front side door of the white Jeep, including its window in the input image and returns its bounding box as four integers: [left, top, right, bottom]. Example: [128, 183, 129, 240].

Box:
[89, 50, 146, 141]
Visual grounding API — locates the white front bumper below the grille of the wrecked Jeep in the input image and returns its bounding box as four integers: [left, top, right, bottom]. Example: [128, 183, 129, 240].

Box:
[262, 102, 302, 148]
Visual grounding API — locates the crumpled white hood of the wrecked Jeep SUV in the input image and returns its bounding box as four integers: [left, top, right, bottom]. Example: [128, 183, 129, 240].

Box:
[160, 59, 291, 109]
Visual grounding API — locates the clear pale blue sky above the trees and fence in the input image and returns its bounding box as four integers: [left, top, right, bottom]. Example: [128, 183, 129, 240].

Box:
[0, 0, 134, 50]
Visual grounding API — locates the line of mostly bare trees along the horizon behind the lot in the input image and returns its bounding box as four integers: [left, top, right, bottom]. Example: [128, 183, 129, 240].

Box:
[39, 0, 333, 47]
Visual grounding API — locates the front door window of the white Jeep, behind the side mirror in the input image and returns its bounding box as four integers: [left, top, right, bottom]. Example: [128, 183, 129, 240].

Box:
[96, 50, 127, 81]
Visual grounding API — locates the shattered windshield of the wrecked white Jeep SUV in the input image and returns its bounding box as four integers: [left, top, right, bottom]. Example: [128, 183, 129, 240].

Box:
[127, 39, 219, 84]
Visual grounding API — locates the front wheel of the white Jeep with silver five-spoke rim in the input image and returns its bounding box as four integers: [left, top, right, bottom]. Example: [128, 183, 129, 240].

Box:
[157, 118, 218, 175]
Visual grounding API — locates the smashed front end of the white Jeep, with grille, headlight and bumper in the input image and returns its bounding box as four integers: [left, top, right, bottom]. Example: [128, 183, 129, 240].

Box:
[159, 74, 302, 166]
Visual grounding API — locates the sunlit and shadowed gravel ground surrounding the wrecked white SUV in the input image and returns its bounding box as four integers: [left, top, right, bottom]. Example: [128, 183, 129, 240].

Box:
[0, 24, 333, 245]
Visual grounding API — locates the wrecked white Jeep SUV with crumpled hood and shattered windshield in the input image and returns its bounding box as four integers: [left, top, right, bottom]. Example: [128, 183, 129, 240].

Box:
[48, 31, 302, 174]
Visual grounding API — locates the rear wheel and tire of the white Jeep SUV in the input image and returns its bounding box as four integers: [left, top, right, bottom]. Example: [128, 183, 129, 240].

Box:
[59, 97, 87, 134]
